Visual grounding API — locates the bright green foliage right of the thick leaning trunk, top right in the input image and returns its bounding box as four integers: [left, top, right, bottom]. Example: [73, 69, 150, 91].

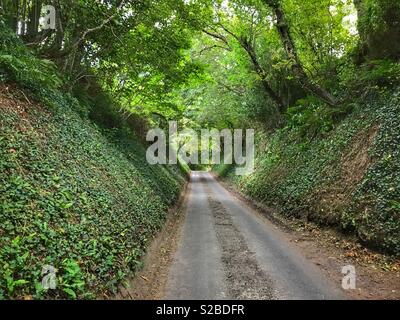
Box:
[282, 0, 357, 87]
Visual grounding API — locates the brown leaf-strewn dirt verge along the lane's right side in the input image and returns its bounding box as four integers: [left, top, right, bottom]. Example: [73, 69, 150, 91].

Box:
[210, 172, 400, 300]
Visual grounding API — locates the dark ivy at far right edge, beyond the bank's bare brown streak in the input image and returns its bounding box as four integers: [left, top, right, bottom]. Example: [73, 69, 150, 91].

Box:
[343, 91, 400, 254]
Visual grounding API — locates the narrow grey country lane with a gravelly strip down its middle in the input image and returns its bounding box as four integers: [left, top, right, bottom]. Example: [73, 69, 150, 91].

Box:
[165, 172, 344, 300]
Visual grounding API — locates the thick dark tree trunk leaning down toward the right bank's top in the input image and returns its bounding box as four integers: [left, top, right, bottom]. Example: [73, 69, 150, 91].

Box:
[264, 0, 337, 106]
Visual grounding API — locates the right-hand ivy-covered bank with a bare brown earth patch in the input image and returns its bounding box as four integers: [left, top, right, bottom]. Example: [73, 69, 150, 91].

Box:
[215, 88, 400, 255]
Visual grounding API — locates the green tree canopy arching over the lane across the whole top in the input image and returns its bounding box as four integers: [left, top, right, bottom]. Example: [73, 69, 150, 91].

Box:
[0, 0, 400, 127]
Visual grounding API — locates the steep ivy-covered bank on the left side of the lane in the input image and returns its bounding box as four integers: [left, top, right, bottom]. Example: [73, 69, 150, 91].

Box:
[0, 28, 185, 299]
